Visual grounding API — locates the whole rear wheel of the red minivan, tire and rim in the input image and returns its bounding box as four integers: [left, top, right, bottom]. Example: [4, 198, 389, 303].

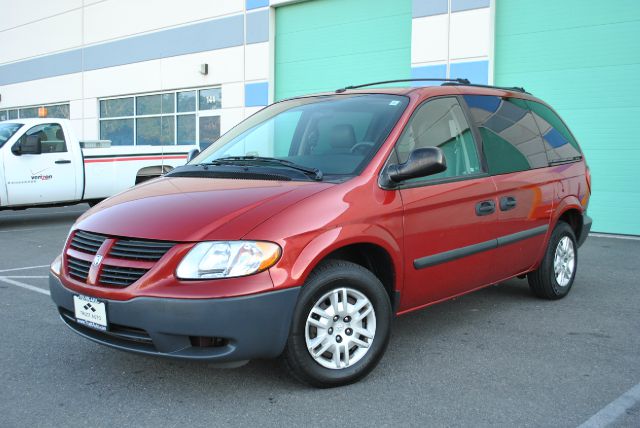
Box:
[527, 221, 578, 300]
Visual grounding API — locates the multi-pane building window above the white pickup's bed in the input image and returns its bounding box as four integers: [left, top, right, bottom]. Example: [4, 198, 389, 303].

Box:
[100, 87, 222, 146]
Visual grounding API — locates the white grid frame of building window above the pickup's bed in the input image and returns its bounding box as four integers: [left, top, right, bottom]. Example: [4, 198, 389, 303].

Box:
[97, 85, 223, 147]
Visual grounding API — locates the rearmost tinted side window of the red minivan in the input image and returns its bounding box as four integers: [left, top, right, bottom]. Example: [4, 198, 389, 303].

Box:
[527, 101, 581, 162]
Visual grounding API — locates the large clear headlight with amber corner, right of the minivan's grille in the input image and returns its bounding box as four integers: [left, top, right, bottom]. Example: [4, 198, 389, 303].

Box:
[176, 241, 281, 279]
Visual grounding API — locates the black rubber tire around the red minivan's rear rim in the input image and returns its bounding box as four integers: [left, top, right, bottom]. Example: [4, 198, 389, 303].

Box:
[527, 221, 578, 300]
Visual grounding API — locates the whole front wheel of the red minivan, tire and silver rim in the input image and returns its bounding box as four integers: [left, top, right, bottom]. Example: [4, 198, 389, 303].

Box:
[284, 260, 393, 388]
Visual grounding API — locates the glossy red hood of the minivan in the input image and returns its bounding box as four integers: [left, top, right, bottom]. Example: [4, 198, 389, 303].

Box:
[74, 177, 332, 242]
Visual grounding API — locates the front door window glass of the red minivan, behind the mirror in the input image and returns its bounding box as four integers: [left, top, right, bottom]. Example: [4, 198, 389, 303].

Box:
[396, 98, 480, 182]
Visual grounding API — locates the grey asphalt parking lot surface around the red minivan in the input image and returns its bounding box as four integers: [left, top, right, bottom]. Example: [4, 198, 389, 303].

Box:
[0, 205, 640, 427]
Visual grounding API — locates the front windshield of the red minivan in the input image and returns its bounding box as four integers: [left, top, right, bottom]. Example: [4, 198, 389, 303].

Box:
[190, 94, 409, 178]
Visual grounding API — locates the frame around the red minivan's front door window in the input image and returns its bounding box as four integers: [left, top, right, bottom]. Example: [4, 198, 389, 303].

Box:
[378, 94, 490, 190]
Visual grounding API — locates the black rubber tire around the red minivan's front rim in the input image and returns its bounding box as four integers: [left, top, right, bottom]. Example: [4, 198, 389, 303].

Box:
[284, 260, 393, 388]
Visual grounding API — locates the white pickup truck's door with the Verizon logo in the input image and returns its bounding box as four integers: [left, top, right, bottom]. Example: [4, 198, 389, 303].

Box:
[3, 123, 76, 205]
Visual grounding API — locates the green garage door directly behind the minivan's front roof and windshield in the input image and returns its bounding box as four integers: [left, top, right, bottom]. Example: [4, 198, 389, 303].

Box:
[275, 0, 411, 100]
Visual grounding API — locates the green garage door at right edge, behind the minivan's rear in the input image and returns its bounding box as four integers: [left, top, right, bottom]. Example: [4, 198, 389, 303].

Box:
[494, 0, 640, 235]
